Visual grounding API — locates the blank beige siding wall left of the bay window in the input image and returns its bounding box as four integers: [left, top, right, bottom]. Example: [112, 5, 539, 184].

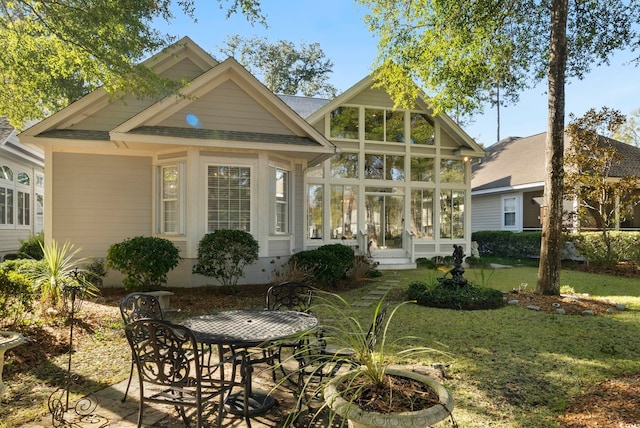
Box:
[52, 153, 152, 257]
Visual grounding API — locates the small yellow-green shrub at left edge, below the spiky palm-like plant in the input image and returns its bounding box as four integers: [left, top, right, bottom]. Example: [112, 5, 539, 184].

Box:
[0, 269, 35, 325]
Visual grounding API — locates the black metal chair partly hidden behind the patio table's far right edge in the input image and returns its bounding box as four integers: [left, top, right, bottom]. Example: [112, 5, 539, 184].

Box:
[265, 281, 313, 383]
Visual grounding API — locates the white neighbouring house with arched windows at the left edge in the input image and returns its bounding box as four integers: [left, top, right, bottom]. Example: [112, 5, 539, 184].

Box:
[0, 117, 44, 258]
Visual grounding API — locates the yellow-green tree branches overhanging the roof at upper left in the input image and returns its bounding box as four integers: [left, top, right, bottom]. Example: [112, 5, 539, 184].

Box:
[0, 0, 265, 128]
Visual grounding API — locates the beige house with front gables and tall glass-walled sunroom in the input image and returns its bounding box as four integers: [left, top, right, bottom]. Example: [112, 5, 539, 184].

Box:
[20, 38, 484, 286]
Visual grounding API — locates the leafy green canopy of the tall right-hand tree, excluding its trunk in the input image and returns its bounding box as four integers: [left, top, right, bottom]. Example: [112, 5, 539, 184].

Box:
[358, 0, 640, 117]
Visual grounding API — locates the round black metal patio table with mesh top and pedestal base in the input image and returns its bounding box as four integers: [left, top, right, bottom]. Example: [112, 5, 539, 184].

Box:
[181, 310, 318, 415]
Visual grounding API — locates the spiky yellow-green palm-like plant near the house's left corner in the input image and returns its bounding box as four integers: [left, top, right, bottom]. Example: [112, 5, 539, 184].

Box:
[31, 239, 97, 308]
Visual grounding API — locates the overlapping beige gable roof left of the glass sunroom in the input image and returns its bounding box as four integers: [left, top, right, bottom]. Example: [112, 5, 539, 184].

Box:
[23, 38, 335, 163]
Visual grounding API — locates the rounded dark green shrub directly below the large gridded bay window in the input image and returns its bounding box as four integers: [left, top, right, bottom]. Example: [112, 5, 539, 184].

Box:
[193, 229, 259, 288]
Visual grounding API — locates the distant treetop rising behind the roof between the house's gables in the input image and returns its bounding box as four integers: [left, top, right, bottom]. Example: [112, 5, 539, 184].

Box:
[220, 34, 337, 97]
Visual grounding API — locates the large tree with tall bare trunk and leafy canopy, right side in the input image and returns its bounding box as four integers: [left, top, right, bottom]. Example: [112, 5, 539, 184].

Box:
[358, 0, 640, 294]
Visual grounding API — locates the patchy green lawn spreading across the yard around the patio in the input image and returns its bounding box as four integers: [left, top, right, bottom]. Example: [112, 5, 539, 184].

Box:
[0, 266, 640, 428]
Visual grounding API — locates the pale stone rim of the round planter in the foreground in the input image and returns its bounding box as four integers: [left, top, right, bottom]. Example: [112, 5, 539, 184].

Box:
[324, 368, 453, 428]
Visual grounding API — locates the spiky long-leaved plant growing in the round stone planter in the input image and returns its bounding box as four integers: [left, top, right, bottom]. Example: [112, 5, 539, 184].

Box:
[292, 291, 453, 426]
